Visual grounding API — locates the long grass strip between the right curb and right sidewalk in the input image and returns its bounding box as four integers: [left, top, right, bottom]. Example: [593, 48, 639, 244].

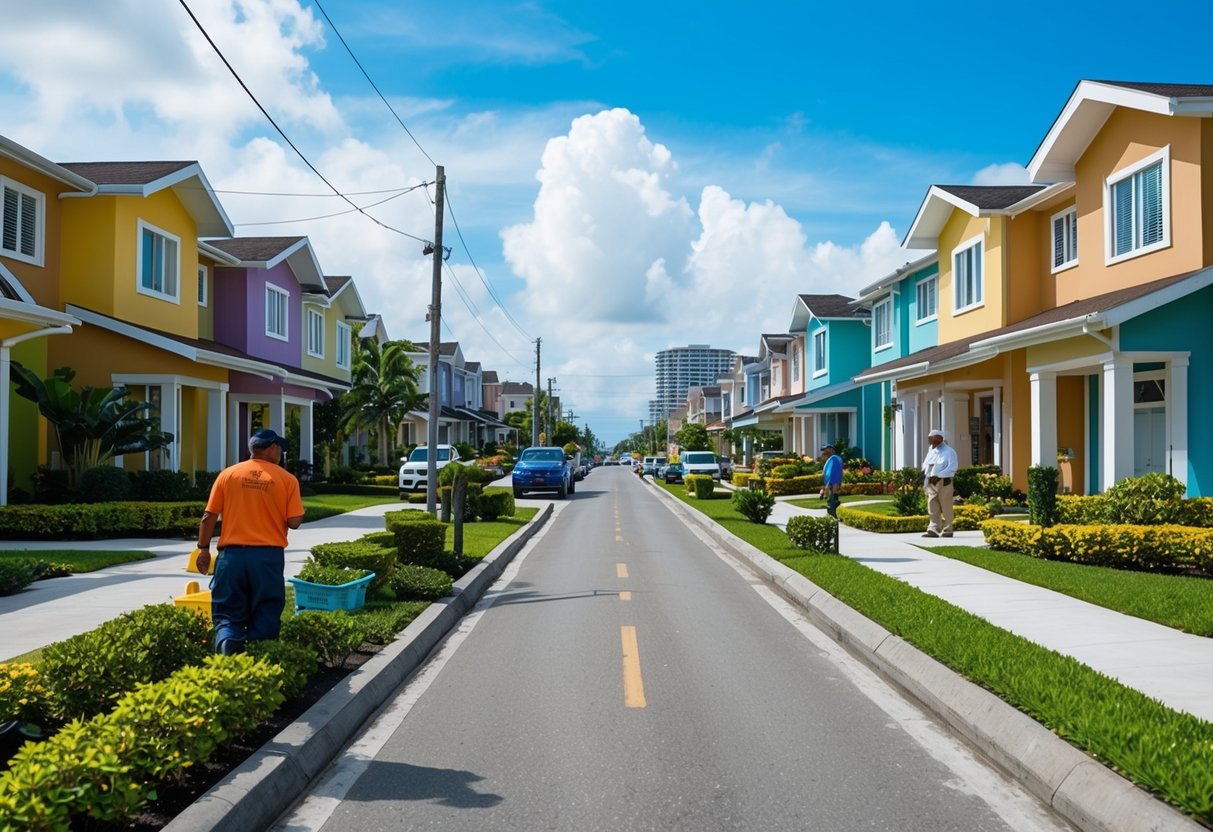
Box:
[655, 489, 1213, 826]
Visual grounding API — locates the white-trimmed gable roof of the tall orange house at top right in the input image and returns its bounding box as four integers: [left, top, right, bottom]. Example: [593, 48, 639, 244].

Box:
[1027, 80, 1213, 182]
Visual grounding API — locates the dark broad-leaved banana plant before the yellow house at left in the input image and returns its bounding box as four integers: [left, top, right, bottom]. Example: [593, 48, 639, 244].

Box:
[10, 361, 173, 484]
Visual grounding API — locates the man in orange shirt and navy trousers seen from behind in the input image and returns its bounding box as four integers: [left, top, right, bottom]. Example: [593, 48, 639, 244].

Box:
[198, 429, 303, 655]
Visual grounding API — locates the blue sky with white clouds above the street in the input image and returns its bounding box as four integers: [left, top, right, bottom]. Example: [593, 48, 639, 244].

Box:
[0, 0, 1213, 441]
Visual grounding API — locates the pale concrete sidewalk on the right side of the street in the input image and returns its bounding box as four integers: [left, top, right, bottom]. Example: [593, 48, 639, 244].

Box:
[770, 497, 1213, 722]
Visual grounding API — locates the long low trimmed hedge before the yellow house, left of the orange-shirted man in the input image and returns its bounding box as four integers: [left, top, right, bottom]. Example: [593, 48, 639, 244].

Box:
[0, 502, 206, 540]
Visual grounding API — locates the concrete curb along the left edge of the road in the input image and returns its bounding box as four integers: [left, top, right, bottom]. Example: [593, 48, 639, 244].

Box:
[164, 503, 553, 832]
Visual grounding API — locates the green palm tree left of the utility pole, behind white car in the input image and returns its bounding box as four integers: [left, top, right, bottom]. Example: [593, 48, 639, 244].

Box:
[342, 338, 426, 466]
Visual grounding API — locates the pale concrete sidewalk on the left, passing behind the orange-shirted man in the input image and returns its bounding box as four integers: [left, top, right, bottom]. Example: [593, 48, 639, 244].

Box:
[0, 503, 409, 661]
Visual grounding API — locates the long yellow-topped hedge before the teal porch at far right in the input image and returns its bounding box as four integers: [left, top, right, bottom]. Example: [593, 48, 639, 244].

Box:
[981, 520, 1213, 575]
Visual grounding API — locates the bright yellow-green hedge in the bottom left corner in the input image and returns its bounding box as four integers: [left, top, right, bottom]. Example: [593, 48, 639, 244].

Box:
[0, 655, 284, 832]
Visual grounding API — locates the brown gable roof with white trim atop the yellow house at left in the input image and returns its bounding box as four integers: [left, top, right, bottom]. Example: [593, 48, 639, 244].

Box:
[62, 161, 235, 237]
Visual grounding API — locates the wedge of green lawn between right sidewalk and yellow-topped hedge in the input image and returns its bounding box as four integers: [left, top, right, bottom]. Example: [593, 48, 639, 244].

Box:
[929, 546, 1213, 636]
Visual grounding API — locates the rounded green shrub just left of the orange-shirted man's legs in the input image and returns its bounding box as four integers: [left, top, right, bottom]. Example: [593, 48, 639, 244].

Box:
[41, 604, 211, 719]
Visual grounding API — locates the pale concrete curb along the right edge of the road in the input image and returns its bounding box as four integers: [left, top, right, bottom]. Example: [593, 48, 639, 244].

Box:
[655, 486, 1207, 832]
